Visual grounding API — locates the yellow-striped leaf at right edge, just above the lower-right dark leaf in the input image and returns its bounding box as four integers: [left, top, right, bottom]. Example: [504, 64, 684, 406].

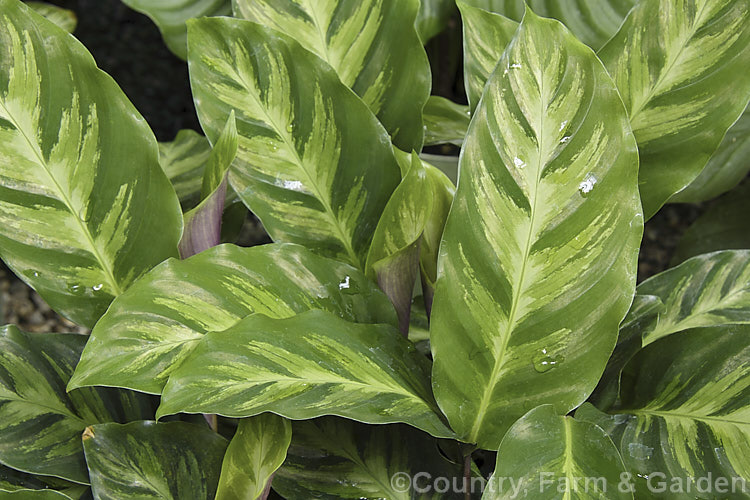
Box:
[638, 250, 750, 346]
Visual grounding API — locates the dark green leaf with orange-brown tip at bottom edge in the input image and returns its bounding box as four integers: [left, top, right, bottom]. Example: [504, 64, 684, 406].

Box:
[83, 422, 227, 500]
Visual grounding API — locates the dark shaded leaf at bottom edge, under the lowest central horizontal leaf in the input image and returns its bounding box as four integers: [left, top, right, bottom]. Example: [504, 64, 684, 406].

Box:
[273, 417, 464, 500]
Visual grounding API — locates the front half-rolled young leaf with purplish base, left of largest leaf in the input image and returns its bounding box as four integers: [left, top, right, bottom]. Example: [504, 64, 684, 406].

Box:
[366, 153, 432, 335]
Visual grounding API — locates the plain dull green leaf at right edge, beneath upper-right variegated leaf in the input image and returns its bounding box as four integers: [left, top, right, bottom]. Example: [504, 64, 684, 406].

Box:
[669, 106, 750, 203]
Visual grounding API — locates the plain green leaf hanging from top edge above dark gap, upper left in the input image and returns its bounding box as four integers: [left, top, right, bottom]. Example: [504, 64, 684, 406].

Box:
[122, 0, 232, 59]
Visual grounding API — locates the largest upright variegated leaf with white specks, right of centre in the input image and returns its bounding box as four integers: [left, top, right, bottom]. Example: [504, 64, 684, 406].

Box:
[431, 11, 643, 449]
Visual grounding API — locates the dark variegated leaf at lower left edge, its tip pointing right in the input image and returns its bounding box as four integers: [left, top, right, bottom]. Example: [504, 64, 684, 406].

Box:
[0, 326, 153, 484]
